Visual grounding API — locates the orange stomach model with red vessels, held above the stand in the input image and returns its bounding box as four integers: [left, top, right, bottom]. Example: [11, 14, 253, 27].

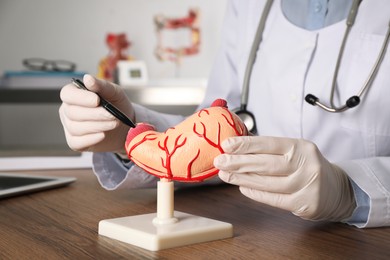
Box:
[125, 99, 248, 182]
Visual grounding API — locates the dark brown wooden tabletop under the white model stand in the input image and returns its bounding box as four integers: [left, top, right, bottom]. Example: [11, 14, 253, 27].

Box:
[0, 170, 390, 259]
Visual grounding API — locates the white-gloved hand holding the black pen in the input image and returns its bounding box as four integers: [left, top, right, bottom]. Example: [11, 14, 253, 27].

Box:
[59, 75, 134, 152]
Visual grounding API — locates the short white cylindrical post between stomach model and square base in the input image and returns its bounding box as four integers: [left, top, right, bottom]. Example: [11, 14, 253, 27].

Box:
[153, 179, 177, 225]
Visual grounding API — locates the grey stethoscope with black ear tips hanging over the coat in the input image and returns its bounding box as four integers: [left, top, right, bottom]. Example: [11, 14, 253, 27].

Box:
[234, 0, 390, 134]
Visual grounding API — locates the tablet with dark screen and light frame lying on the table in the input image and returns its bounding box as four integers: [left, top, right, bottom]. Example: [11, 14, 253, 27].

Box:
[0, 173, 76, 198]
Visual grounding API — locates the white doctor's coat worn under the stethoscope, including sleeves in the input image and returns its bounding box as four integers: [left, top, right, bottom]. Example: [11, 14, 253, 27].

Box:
[94, 0, 390, 227]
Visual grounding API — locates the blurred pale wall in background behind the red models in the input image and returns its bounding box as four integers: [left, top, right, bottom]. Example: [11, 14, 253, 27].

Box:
[0, 0, 225, 78]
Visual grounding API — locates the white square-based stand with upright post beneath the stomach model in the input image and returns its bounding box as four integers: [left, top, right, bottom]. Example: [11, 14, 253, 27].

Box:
[99, 180, 233, 251]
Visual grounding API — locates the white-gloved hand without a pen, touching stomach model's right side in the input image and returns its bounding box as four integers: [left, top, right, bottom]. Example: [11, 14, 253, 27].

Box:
[214, 136, 356, 221]
